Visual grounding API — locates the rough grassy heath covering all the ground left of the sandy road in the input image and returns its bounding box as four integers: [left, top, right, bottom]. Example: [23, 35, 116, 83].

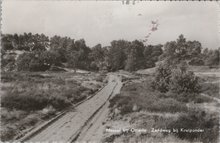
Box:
[1, 72, 105, 141]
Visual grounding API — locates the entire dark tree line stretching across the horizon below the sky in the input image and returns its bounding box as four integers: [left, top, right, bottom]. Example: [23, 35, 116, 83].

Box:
[1, 33, 219, 71]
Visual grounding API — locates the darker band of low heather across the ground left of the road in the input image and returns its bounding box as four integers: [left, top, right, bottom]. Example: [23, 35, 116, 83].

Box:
[2, 82, 86, 111]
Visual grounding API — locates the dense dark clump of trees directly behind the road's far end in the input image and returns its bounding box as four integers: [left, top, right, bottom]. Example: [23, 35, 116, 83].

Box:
[105, 40, 162, 71]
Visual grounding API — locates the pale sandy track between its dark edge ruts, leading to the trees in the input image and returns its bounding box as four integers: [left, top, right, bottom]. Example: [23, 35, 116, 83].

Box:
[25, 75, 120, 143]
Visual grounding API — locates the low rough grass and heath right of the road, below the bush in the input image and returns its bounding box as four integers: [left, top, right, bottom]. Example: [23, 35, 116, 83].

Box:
[106, 77, 219, 143]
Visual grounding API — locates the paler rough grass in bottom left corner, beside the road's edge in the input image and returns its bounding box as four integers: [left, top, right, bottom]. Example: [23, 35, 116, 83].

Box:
[0, 108, 54, 142]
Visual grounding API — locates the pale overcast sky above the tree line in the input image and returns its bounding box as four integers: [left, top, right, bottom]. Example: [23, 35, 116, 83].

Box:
[2, 0, 220, 49]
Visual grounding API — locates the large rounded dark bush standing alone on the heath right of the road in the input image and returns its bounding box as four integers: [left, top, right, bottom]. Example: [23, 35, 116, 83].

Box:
[152, 63, 201, 94]
